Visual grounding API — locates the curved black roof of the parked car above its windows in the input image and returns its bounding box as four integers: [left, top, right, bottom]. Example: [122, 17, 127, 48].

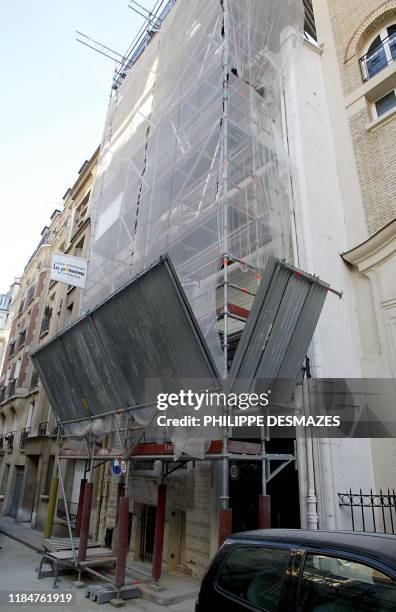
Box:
[227, 529, 396, 566]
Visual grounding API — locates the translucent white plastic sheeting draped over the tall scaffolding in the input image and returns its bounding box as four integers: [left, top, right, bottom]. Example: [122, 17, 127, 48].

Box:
[82, 0, 304, 372]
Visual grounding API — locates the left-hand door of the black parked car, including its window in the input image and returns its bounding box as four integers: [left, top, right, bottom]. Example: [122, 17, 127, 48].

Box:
[210, 543, 290, 612]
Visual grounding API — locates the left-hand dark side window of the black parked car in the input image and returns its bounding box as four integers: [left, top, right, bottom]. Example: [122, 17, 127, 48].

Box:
[217, 546, 289, 612]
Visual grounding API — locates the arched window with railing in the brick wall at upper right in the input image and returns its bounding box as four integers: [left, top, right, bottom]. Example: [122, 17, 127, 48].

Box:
[360, 24, 396, 81]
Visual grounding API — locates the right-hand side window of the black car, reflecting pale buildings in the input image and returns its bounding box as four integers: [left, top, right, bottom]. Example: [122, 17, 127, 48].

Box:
[298, 554, 396, 612]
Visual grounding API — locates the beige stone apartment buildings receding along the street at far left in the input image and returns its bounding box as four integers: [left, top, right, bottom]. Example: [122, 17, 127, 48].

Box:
[0, 151, 97, 528]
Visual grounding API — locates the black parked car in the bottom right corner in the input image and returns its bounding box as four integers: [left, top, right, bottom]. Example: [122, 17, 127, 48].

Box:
[196, 529, 396, 612]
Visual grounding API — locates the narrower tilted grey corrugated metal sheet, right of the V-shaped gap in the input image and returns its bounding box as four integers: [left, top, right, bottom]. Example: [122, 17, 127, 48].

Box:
[229, 259, 328, 393]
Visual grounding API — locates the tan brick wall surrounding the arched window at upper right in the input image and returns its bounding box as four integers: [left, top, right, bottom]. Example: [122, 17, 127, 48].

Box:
[316, 0, 396, 235]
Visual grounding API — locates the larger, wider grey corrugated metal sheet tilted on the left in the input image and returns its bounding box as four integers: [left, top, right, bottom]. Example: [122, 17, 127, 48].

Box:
[32, 258, 219, 422]
